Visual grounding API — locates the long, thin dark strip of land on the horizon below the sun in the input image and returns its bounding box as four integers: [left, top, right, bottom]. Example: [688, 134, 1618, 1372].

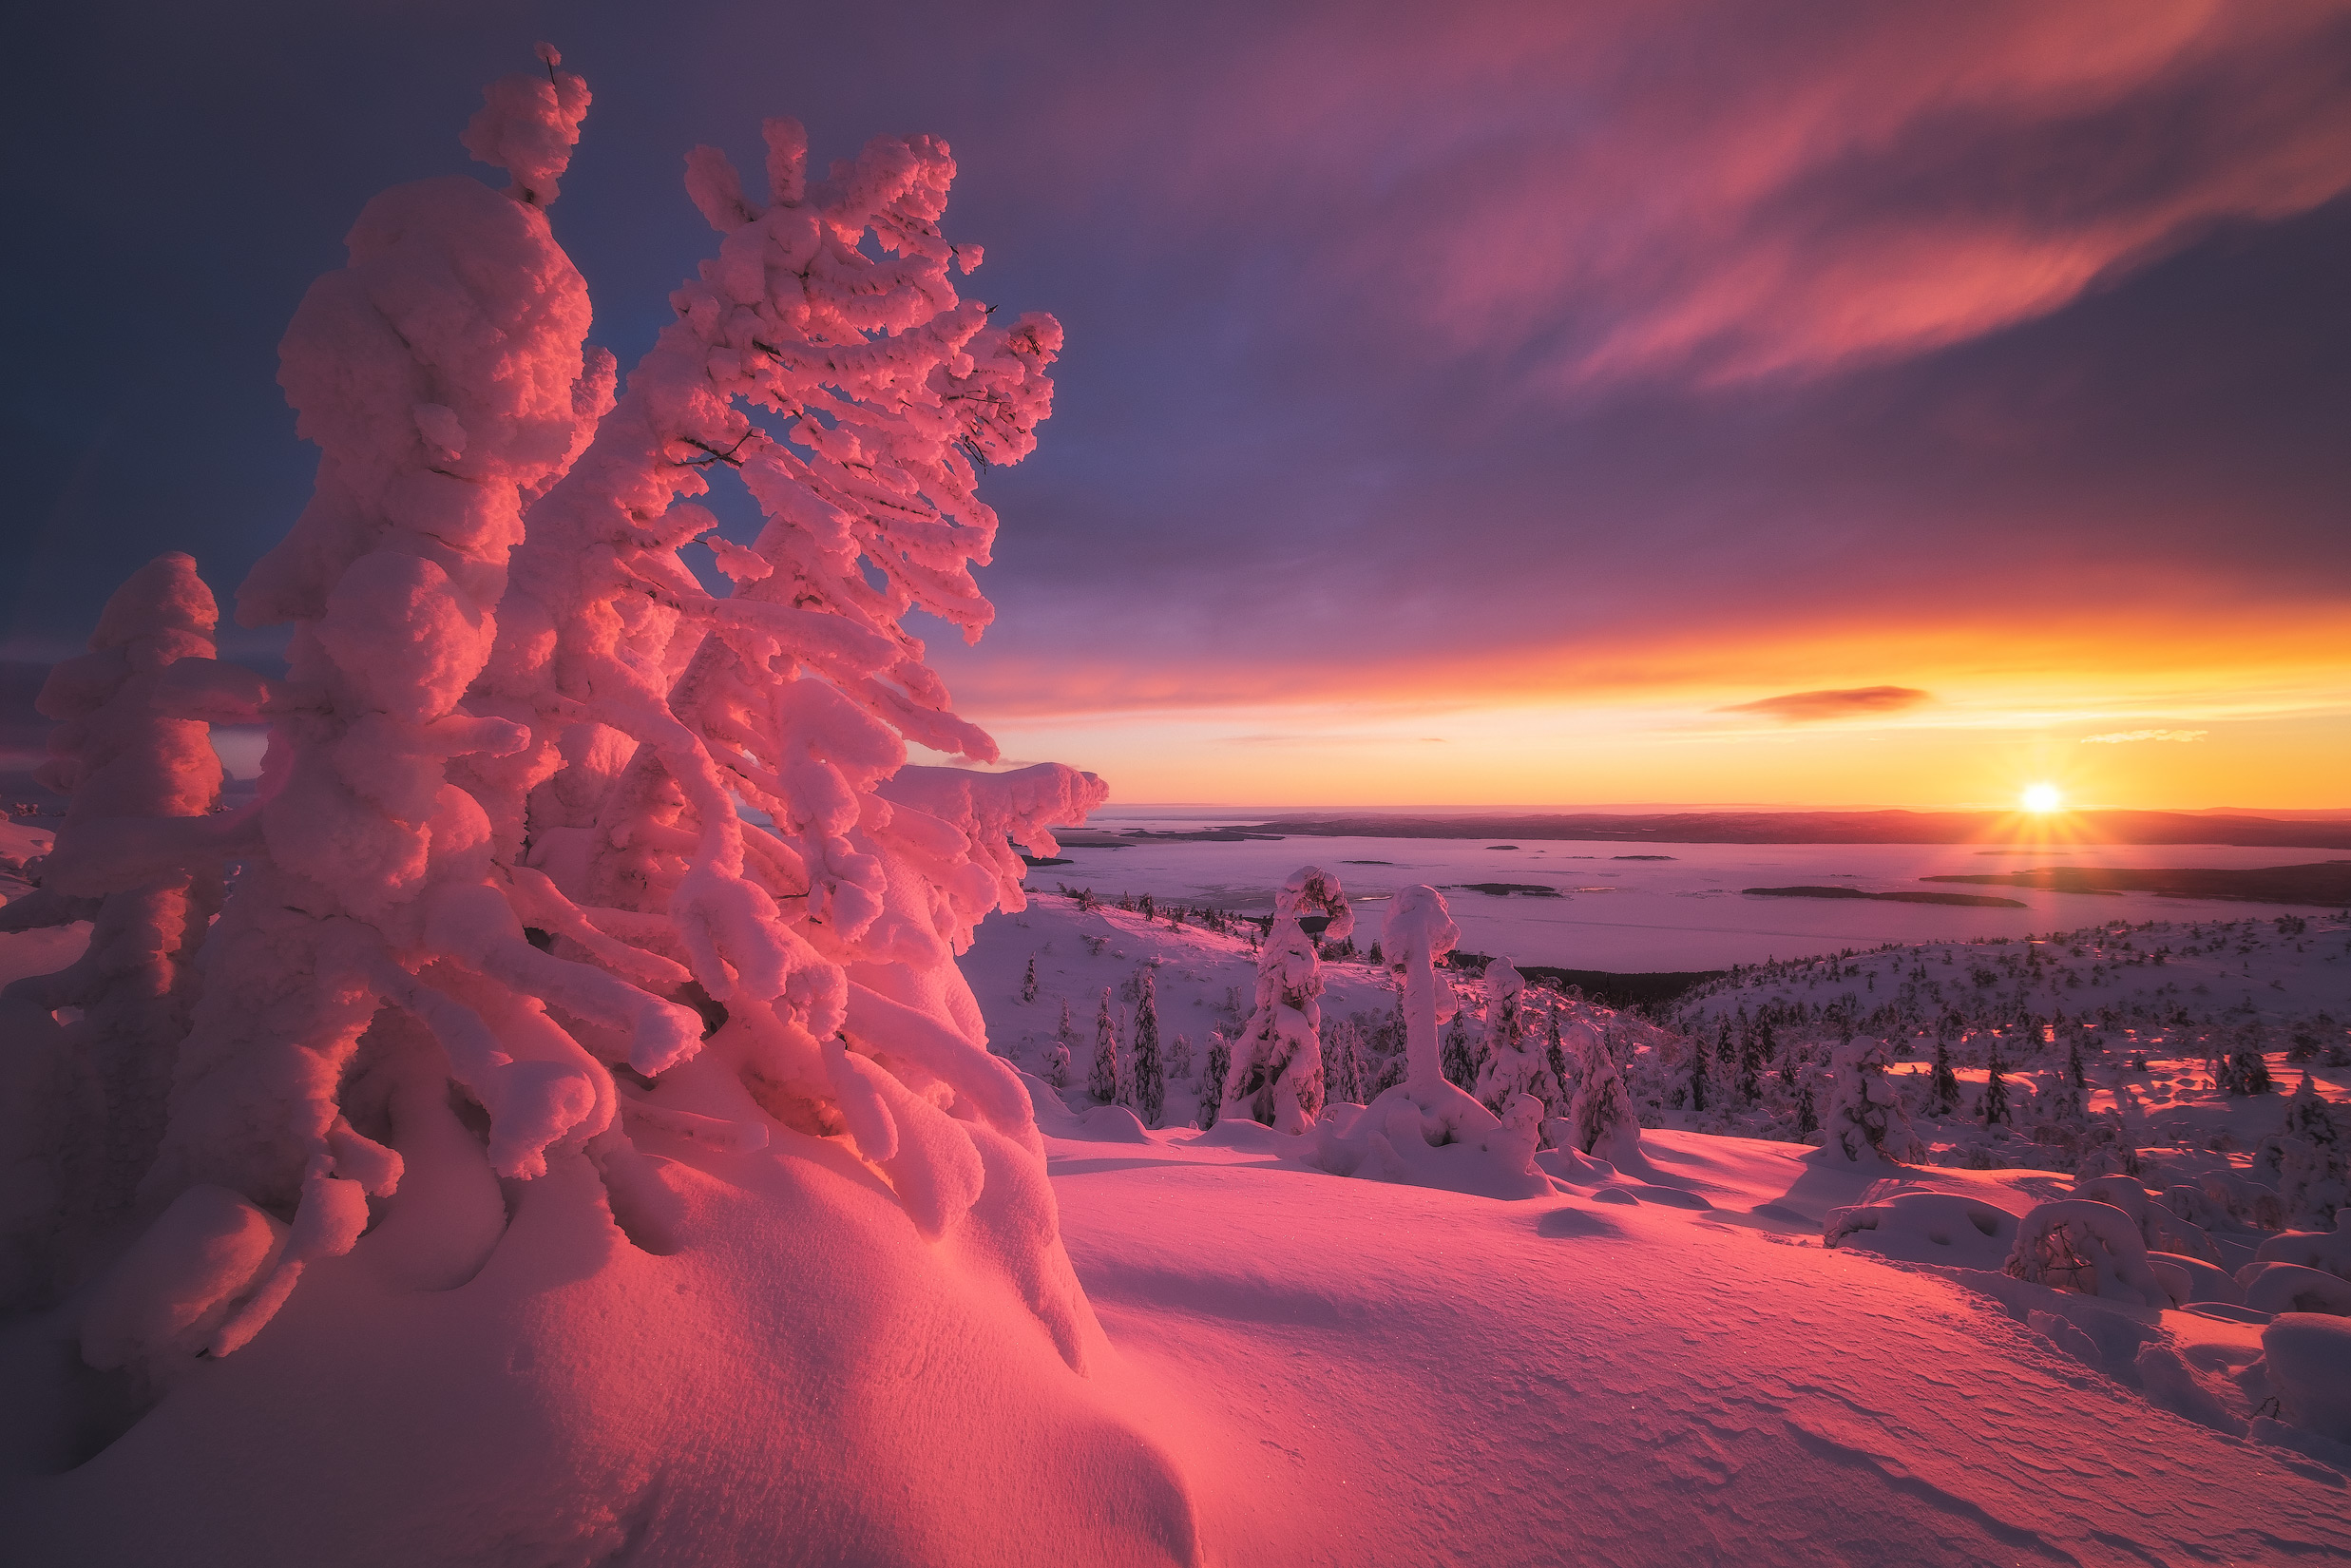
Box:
[1218, 811, 2351, 853]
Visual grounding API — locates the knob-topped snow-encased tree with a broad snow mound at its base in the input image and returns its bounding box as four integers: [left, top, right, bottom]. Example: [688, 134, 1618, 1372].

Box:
[1311, 887, 1552, 1199]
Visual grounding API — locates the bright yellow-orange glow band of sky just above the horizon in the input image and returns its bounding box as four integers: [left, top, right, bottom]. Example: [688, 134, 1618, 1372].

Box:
[949, 594, 2351, 808]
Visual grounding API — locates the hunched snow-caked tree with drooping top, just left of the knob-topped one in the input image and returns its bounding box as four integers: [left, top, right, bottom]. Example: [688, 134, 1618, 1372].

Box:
[1218, 865, 1354, 1133]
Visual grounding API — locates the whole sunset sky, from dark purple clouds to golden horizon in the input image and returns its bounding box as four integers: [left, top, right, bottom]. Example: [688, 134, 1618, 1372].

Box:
[0, 0, 2351, 811]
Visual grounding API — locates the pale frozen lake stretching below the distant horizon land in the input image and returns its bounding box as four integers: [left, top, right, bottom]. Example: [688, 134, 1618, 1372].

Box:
[1027, 820, 2344, 973]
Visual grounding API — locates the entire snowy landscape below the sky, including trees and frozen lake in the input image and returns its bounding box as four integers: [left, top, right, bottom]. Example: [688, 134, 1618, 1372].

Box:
[0, 21, 2351, 1568]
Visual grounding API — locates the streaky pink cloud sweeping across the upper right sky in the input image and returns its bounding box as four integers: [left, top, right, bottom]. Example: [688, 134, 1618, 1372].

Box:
[1075, 0, 2351, 388]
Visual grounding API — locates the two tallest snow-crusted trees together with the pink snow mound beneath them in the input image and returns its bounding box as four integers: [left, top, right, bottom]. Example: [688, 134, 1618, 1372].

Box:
[11, 51, 1195, 1561]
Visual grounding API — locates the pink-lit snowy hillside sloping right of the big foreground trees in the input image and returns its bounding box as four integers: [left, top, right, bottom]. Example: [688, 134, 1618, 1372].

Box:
[964, 898, 2351, 1563]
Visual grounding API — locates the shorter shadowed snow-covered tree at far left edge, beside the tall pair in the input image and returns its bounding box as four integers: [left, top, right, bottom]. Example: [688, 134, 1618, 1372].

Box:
[0, 552, 221, 1310]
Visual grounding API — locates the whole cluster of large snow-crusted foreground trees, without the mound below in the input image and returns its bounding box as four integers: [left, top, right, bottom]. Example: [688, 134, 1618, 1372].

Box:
[0, 51, 1109, 1356]
